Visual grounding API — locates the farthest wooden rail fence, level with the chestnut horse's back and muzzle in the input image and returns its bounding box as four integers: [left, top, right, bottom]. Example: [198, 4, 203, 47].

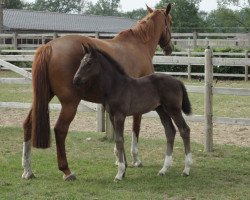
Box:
[0, 32, 250, 49]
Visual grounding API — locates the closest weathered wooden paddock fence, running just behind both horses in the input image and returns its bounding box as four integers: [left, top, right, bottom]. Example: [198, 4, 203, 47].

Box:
[0, 49, 250, 152]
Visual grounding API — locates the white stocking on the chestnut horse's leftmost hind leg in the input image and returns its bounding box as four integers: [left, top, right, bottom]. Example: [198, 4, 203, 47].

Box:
[22, 140, 34, 179]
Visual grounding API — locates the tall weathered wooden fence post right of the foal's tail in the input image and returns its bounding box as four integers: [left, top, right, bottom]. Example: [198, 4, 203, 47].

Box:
[204, 47, 213, 152]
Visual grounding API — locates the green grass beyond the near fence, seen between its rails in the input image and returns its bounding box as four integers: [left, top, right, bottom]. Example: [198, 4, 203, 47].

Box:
[0, 72, 250, 118]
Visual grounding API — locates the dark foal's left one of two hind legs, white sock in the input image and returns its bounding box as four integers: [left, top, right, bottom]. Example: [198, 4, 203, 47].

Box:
[156, 106, 176, 176]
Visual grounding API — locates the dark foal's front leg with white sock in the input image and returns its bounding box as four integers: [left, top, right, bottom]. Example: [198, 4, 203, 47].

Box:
[114, 115, 127, 181]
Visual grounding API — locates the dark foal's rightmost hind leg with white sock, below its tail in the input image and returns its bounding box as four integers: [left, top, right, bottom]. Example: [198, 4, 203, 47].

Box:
[171, 111, 192, 176]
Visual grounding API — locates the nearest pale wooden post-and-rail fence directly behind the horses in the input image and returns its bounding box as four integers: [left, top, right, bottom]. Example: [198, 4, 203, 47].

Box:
[0, 50, 250, 151]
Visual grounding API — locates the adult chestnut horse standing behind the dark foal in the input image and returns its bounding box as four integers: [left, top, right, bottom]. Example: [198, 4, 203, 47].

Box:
[22, 4, 172, 180]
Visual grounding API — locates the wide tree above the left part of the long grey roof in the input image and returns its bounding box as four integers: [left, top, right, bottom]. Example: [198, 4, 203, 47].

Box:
[28, 0, 85, 13]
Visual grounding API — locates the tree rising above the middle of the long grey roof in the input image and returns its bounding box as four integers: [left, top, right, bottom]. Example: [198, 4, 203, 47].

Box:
[85, 0, 121, 16]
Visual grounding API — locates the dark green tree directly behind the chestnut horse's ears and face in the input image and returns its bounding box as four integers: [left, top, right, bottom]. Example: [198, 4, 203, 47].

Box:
[156, 0, 204, 32]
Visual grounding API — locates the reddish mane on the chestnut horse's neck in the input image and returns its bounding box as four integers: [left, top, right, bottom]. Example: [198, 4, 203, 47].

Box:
[118, 10, 160, 43]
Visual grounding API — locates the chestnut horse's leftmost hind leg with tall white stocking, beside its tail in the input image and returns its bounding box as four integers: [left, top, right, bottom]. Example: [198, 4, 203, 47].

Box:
[22, 109, 34, 179]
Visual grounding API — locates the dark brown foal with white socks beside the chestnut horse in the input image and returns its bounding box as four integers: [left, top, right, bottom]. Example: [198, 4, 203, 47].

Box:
[73, 46, 192, 180]
